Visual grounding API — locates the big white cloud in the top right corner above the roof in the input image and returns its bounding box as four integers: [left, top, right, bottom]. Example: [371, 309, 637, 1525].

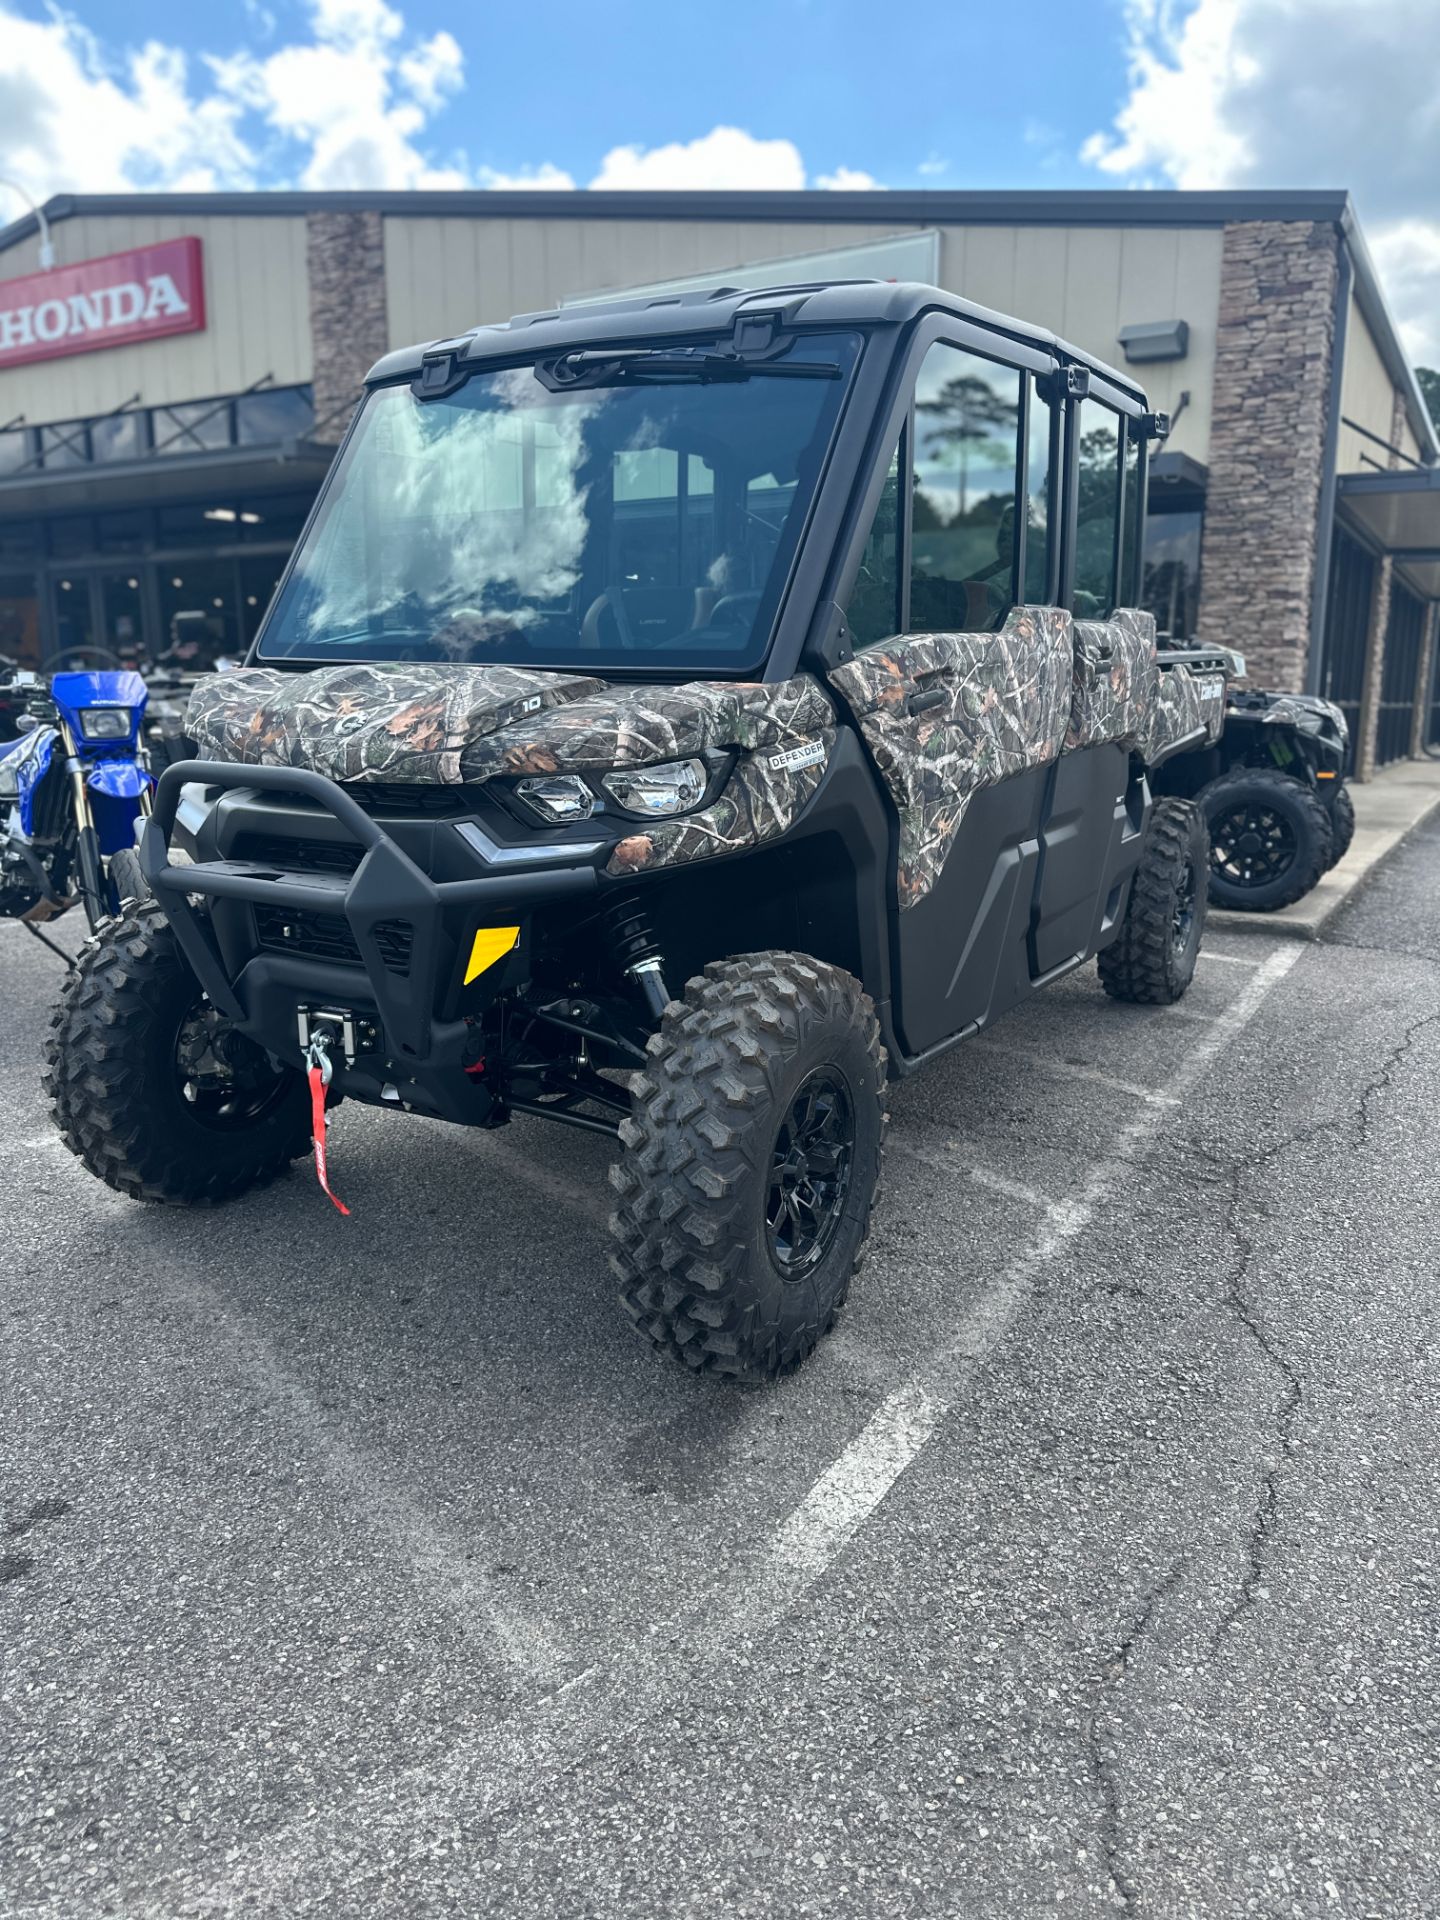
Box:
[1081, 0, 1440, 365]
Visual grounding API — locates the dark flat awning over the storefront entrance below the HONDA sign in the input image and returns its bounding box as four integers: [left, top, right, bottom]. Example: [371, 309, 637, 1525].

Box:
[0, 440, 334, 518]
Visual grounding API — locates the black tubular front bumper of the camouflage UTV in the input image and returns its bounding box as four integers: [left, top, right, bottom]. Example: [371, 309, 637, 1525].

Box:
[140, 760, 599, 1119]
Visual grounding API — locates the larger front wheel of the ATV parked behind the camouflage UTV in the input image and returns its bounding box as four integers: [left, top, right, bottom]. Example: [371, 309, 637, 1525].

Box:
[1200, 766, 1332, 914]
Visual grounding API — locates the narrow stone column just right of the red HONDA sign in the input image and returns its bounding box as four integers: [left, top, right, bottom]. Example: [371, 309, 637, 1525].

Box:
[305, 213, 390, 445]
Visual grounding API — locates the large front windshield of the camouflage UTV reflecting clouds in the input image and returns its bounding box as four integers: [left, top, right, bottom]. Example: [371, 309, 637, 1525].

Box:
[259, 334, 860, 674]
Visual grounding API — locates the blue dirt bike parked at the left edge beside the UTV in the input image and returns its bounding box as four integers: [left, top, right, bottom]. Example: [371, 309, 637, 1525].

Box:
[0, 670, 154, 945]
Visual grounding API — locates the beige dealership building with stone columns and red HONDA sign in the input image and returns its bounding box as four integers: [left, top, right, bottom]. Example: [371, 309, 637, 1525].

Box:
[0, 192, 1440, 778]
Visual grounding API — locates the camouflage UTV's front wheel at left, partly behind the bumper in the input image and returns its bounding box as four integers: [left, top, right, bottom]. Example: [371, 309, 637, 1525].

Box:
[44, 900, 309, 1206]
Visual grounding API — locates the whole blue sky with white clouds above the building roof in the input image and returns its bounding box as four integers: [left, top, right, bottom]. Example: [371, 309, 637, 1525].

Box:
[0, 0, 1440, 365]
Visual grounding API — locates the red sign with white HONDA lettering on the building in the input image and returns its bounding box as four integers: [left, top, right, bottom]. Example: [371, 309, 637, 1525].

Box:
[0, 238, 205, 371]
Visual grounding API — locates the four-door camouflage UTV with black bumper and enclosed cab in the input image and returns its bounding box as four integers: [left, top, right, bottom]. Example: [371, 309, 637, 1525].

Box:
[48, 282, 1225, 1377]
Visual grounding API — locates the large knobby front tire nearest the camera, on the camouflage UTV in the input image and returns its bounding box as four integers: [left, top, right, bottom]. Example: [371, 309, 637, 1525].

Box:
[611, 952, 885, 1379]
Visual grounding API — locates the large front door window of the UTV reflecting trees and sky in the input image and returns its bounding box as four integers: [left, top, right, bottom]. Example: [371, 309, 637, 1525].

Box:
[910, 344, 1021, 634]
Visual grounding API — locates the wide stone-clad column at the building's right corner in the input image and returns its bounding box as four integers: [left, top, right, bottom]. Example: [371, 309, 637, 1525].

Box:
[1198, 221, 1340, 693]
